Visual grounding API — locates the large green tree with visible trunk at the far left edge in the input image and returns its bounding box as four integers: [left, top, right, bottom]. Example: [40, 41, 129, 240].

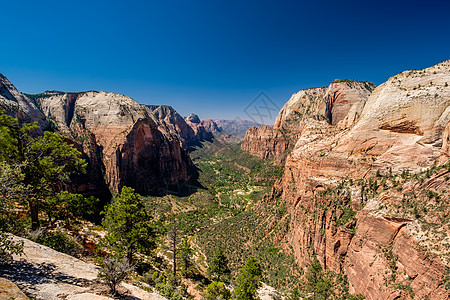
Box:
[0, 112, 86, 230]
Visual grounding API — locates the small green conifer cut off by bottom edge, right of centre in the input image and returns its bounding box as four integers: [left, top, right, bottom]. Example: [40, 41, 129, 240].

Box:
[233, 256, 263, 300]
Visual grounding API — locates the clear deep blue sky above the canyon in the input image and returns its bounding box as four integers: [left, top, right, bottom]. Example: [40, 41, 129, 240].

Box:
[0, 0, 450, 124]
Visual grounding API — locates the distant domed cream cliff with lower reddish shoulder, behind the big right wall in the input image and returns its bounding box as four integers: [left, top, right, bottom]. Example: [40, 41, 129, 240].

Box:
[241, 80, 375, 160]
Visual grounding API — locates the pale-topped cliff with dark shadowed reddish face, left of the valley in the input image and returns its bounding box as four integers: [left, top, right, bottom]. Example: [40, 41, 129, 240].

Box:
[36, 92, 195, 194]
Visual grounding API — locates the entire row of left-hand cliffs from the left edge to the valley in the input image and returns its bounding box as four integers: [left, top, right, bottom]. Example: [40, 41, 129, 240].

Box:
[0, 75, 225, 201]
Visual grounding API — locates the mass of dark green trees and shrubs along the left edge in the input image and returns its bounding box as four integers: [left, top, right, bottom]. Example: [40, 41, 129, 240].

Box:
[0, 112, 96, 257]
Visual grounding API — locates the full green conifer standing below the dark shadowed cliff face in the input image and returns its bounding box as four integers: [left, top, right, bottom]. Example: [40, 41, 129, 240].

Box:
[102, 186, 155, 264]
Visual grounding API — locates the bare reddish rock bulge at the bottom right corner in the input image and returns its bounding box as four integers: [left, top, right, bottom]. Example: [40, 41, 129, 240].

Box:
[344, 211, 448, 300]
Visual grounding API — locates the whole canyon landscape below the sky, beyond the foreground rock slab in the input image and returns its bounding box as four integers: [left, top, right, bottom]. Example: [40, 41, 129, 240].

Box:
[0, 60, 450, 300]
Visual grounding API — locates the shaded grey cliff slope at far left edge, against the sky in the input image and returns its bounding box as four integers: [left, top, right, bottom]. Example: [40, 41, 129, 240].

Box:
[0, 74, 48, 128]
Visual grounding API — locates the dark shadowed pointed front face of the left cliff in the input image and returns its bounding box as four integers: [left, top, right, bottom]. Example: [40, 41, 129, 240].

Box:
[115, 119, 193, 194]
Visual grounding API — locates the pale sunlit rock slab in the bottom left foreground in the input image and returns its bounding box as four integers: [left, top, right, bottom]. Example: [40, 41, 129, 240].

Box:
[0, 237, 165, 300]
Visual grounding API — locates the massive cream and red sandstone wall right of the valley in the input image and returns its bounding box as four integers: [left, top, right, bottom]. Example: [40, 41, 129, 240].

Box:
[241, 60, 450, 299]
